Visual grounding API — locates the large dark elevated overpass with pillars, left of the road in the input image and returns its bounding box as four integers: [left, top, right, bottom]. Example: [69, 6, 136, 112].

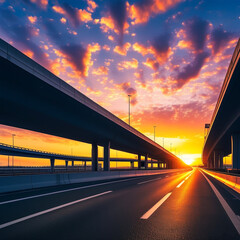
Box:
[0, 39, 186, 171]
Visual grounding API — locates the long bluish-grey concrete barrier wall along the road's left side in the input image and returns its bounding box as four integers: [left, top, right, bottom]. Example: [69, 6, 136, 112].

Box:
[0, 169, 189, 193]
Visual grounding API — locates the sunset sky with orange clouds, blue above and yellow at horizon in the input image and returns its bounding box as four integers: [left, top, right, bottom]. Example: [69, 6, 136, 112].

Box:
[0, 0, 240, 167]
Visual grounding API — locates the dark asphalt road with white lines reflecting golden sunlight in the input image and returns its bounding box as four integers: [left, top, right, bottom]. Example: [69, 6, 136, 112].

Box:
[0, 169, 240, 240]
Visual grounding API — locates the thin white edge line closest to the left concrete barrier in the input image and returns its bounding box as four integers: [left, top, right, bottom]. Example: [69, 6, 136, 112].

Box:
[0, 177, 140, 205]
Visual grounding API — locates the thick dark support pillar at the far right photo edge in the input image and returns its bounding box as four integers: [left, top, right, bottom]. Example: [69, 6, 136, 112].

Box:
[231, 133, 240, 169]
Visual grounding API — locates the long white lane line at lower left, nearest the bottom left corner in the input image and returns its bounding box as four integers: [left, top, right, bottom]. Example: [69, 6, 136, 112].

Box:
[0, 191, 112, 229]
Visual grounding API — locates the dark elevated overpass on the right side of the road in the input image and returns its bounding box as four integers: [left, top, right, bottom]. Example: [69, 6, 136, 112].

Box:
[202, 39, 240, 169]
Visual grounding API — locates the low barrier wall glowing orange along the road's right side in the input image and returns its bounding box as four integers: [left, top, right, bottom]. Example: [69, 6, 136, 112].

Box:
[202, 169, 240, 193]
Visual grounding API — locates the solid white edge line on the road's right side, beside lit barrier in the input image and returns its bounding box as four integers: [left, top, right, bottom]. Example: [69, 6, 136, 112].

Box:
[200, 171, 240, 234]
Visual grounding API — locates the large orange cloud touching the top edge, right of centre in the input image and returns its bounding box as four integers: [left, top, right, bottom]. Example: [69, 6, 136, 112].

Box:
[129, 0, 182, 25]
